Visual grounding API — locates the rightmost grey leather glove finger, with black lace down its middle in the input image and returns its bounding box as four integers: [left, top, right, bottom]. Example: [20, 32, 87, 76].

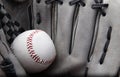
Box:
[88, 0, 120, 76]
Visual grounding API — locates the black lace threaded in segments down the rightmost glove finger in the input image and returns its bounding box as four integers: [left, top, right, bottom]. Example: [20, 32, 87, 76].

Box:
[99, 26, 112, 64]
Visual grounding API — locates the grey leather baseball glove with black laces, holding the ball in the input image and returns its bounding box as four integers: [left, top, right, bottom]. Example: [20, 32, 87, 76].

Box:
[1, 0, 120, 77]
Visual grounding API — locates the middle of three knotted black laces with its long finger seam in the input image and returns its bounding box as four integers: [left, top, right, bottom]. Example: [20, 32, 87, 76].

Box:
[69, 0, 85, 54]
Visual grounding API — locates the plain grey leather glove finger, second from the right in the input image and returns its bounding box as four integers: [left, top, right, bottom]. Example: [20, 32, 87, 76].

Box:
[67, 0, 96, 76]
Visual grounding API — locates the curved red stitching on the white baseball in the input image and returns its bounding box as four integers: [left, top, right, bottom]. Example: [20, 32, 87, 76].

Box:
[26, 30, 54, 64]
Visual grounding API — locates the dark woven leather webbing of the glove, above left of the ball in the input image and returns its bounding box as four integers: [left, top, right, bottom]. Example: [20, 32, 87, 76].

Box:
[0, 4, 24, 44]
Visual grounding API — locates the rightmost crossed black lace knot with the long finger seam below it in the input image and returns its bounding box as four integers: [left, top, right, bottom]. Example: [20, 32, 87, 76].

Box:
[88, 0, 108, 62]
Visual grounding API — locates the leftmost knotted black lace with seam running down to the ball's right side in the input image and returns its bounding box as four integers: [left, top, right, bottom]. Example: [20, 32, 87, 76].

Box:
[45, 0, 63, 42]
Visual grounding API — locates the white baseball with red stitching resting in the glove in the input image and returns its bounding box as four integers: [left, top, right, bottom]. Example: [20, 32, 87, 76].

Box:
[11, 30, 56, 73]
